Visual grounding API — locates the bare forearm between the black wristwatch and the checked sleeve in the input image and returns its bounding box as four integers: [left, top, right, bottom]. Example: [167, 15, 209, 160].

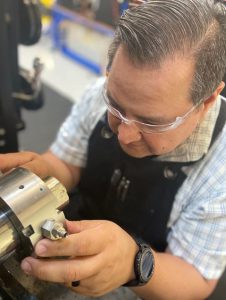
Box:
[133, 253, 217, 300]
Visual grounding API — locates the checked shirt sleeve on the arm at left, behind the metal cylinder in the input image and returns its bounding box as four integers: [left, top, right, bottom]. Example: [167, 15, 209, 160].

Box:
[50, 78, 106, 167]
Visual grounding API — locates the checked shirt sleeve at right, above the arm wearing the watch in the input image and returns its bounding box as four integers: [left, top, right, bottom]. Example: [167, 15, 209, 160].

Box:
[167, 126, 226, 280]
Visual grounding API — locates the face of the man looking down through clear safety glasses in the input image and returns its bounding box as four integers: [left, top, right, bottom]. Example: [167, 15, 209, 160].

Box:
[107, 47, 207, 158]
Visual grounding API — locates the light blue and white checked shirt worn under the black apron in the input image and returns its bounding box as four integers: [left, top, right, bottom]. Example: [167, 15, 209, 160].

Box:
[51, 78, 226, 279]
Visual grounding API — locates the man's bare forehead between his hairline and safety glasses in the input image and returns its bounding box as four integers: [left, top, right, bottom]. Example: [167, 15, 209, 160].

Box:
[108, 48, 194, 111]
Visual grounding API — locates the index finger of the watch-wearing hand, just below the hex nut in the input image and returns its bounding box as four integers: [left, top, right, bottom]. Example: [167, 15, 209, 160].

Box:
[35, 226, 109, 257]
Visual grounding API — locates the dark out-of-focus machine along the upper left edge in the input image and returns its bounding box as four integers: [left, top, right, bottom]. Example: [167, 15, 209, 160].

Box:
[0, 0, 43, 153]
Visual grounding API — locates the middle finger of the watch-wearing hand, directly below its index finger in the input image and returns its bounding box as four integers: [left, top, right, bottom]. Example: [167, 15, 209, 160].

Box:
[21, 255, 103, 283]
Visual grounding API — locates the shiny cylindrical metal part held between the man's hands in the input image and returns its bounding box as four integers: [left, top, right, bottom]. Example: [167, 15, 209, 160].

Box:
[0, 168, 68, 261]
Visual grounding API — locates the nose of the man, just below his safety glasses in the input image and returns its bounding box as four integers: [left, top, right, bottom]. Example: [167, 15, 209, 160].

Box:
[118, 122, 141, 145]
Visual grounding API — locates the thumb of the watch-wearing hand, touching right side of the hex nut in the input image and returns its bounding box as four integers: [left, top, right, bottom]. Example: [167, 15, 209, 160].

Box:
[65, 220, 104, 234]
